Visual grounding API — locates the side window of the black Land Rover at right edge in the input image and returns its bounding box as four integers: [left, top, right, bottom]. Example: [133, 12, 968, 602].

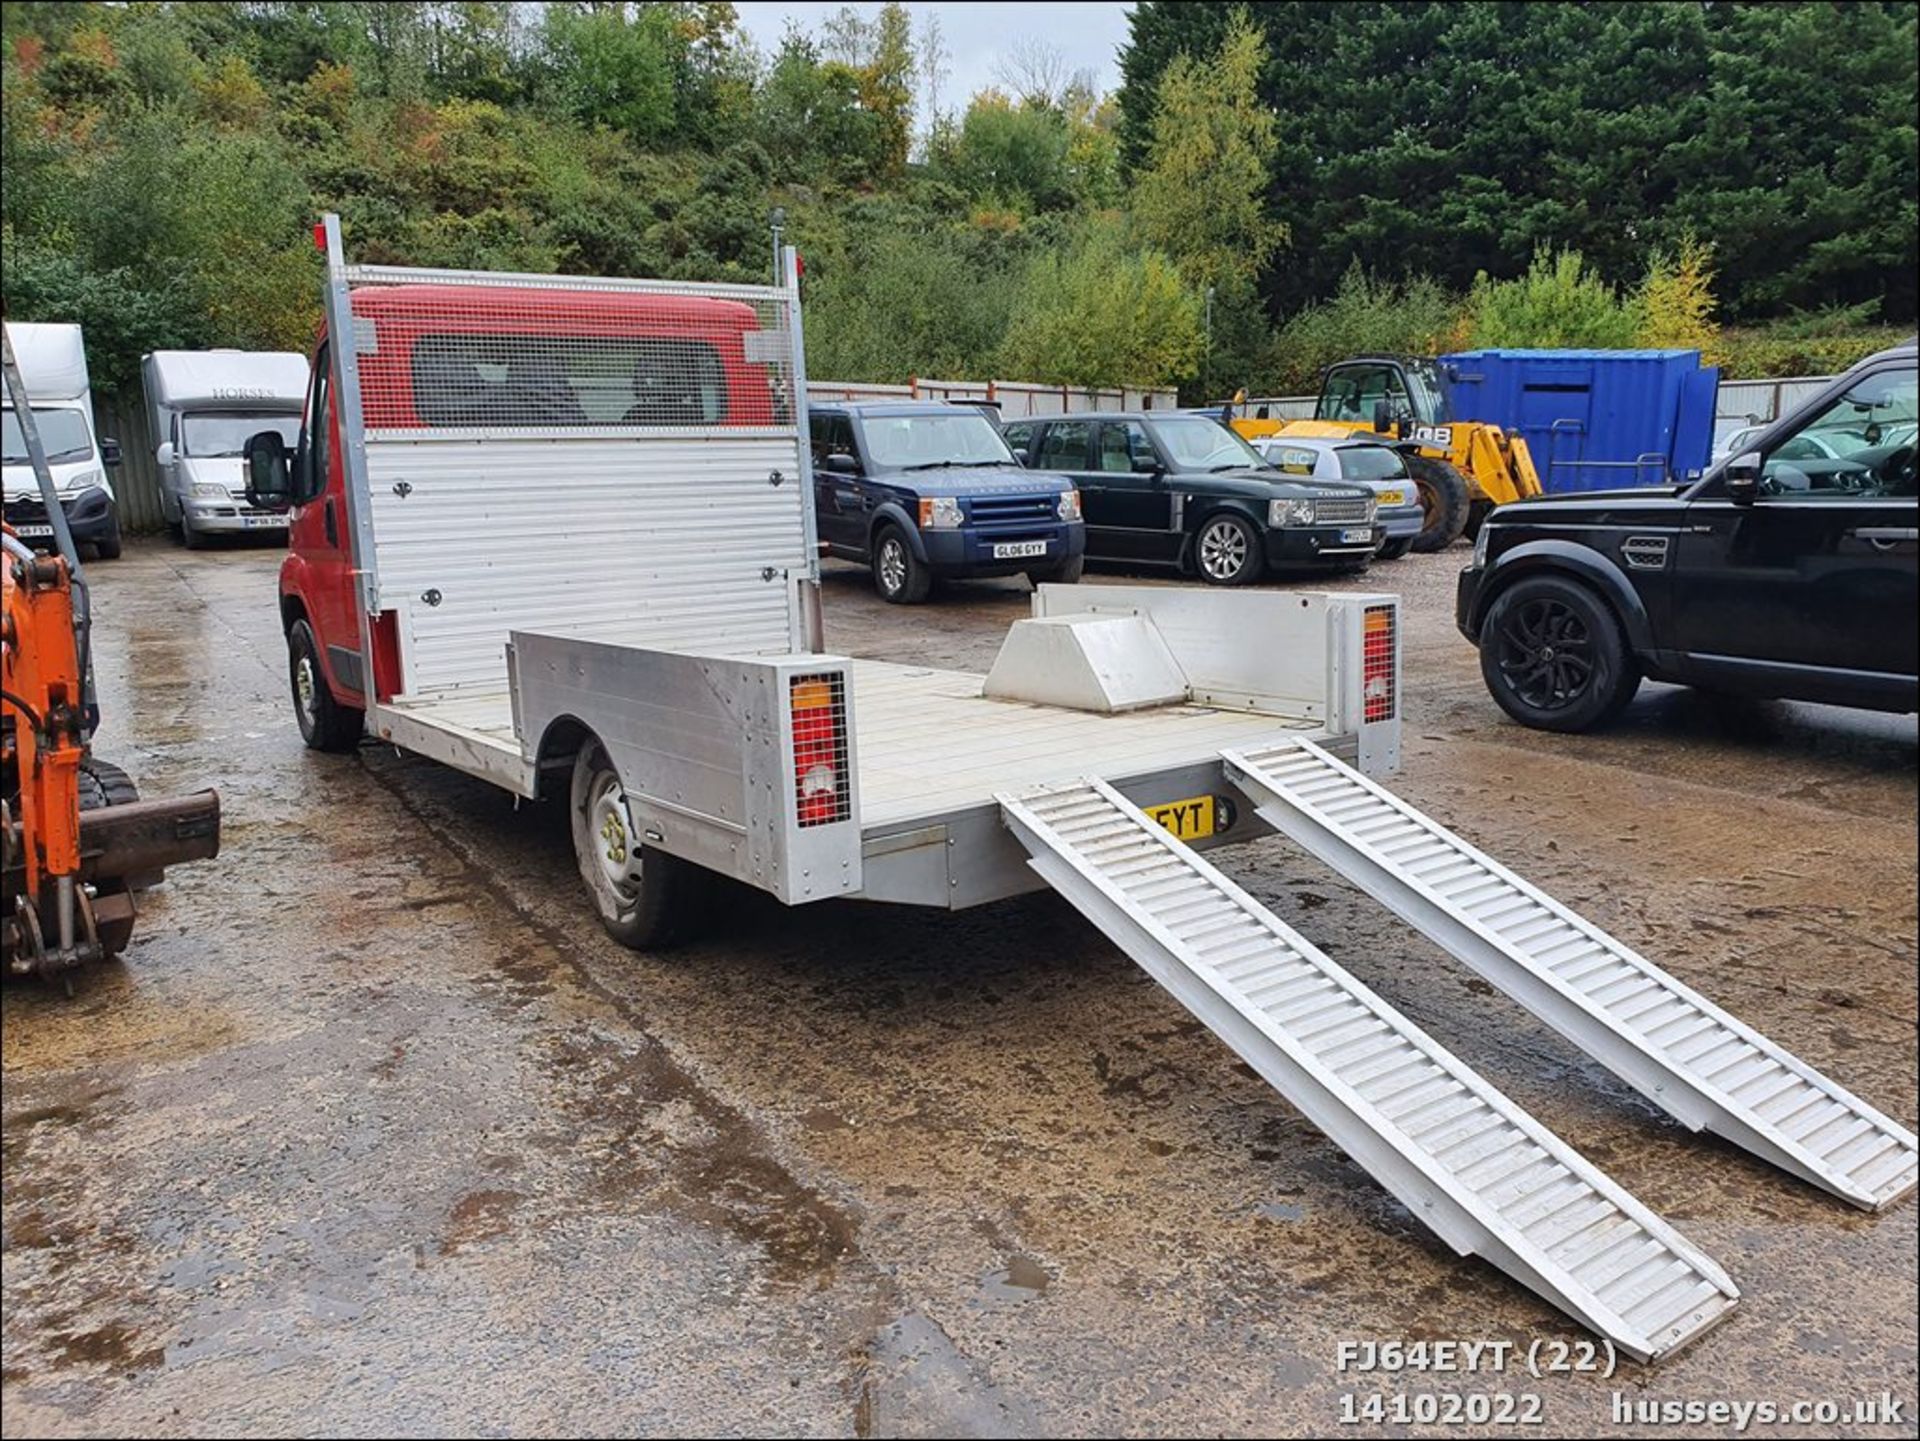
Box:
[1761, 366, 1920, 501]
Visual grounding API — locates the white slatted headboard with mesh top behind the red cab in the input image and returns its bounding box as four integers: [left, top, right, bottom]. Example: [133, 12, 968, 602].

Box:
[346, 267, 810, 700]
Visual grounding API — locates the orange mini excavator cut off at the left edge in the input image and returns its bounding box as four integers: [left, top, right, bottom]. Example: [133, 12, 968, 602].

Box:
[0, 320, 221, 975]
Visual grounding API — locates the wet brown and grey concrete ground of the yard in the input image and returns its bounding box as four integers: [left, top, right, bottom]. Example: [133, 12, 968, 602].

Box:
[4, 545, 1916, 1435]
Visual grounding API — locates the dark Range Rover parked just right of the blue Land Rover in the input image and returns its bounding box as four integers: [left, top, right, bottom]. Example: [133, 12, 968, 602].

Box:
[1000, 411, 1382, 585]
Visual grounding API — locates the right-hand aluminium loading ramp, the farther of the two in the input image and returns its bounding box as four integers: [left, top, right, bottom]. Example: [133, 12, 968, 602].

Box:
[1223, 741, 1920, 1211]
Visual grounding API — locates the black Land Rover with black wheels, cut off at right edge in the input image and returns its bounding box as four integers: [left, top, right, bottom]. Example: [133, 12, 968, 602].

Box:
[1455, 342, 1920, 731]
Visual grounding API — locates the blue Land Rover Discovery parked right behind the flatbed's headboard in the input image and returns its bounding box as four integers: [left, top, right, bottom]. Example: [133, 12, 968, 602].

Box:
[808, 403, 1087, 604]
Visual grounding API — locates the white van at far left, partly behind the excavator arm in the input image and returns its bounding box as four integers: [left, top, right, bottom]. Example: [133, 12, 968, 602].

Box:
[4, 320, 121, 560]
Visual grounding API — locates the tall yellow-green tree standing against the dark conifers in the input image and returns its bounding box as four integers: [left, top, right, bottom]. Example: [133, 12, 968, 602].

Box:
[1133, 10, 1286, 286]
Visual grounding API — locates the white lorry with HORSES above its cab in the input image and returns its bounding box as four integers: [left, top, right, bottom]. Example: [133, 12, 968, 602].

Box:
[140, 351, 307, 549]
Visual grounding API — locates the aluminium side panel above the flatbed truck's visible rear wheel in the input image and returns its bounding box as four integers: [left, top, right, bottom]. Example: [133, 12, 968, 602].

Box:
[513, 629, 860, 906]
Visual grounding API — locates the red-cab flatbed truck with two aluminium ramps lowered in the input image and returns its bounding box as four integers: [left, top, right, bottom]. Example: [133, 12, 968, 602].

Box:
[236, 217, 1912, 1358]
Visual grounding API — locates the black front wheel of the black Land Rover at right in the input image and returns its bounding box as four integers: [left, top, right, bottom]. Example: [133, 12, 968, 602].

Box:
[1480, 576, 1640, 731]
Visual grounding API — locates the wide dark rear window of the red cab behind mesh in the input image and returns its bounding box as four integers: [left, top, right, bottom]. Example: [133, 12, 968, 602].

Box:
[411, 334, 729, 430]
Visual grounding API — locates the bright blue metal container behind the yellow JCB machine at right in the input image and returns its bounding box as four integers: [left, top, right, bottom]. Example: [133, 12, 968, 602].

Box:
[1440, 349, 1720, 491]
